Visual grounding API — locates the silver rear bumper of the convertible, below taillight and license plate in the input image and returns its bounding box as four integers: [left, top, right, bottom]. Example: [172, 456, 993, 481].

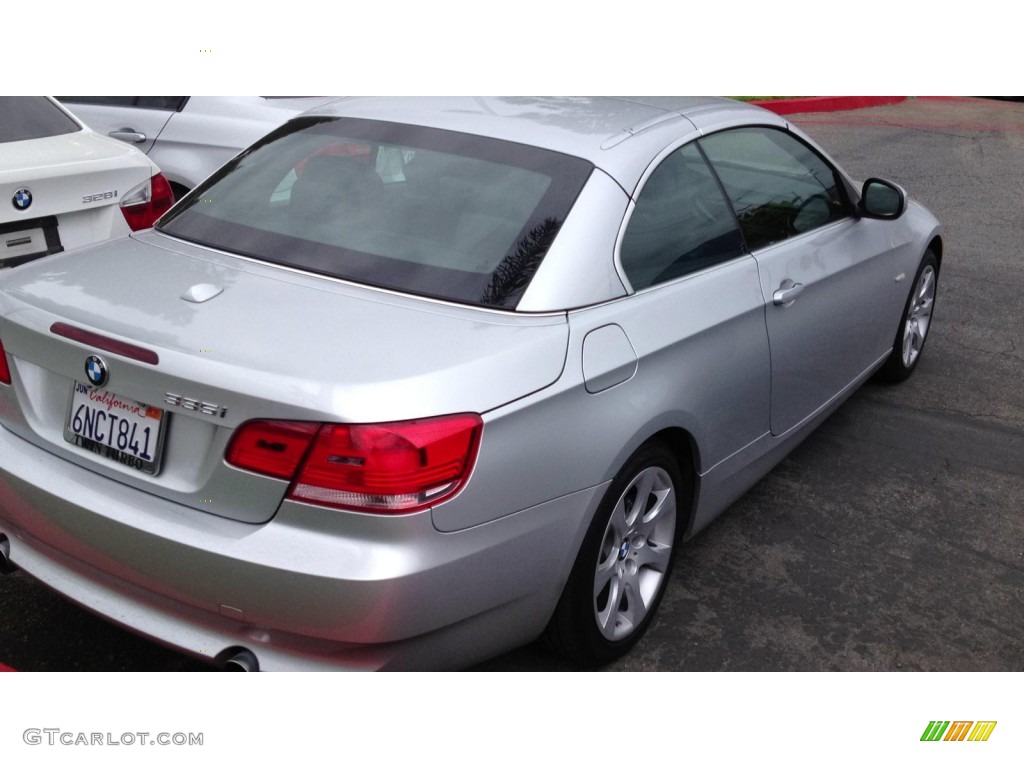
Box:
[0, 428, 603, 670]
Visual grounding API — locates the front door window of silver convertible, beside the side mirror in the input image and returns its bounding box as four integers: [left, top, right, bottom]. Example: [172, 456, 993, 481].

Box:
[698, 127, 852, 250]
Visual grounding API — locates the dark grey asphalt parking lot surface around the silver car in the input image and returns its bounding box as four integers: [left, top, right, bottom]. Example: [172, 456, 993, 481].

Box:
[0, 99, 1024, 671]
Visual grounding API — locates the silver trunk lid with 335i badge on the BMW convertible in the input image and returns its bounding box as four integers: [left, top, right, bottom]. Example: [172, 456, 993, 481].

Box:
[0, 231, 568, 522]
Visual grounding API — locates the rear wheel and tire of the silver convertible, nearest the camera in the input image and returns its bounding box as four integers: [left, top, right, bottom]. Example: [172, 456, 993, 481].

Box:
[544, 442, 691, 669]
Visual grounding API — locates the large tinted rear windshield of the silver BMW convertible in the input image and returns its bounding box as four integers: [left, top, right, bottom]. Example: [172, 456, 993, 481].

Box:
[158, 118, 593, 308]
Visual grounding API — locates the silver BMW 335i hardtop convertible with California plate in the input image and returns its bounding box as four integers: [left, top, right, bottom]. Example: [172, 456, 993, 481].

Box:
[0, 97, 943, 670]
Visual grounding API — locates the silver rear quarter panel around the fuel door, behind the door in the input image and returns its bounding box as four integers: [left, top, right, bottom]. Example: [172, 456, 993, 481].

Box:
[433, 257, 770, 530]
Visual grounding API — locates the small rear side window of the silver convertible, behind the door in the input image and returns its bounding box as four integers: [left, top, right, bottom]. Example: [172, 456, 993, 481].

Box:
[620, 144, 743, 291]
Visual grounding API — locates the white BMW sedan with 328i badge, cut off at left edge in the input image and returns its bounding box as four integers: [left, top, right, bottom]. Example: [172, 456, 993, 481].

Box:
[0, 96, 174, 268]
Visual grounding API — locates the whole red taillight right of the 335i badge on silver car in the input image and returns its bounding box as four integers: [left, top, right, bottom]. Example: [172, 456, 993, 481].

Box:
[226, 414, 483, 514]
